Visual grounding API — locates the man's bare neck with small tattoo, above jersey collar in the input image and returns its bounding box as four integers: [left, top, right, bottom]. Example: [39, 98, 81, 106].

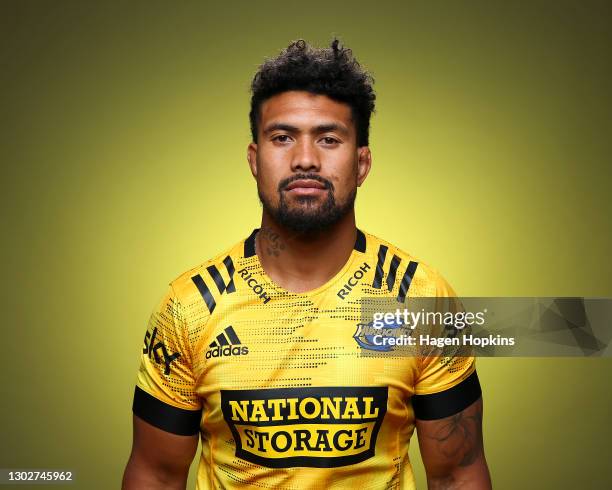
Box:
[255, 210, 357, 293]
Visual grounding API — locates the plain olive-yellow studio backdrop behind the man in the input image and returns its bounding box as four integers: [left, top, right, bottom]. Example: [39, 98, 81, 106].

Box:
[0, 0, 612, 489]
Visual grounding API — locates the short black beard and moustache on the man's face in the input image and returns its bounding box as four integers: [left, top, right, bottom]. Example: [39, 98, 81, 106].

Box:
[257, 174, 357, 235]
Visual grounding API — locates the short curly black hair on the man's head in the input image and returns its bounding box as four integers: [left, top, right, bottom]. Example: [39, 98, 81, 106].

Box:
[249, 38, 376, 146]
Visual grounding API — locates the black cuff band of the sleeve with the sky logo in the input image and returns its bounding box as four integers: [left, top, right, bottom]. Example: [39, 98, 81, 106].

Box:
[132, 386, 202, 436]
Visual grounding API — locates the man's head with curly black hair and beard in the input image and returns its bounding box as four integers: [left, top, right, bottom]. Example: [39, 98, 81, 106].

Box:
[248, 40, 375, 233]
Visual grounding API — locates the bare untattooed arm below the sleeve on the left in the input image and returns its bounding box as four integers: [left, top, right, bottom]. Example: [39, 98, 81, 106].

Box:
[121, 416, 198, 490]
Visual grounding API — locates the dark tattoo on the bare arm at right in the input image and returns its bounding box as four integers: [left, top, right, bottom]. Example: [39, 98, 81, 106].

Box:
[428, 406, 482, 467]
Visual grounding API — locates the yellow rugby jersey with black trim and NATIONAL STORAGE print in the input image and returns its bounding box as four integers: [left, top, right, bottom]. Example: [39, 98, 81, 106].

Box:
[133, 230, 480, 490]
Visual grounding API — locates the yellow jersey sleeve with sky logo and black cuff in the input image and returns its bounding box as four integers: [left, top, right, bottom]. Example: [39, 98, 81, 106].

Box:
[132, 286, 202, 435]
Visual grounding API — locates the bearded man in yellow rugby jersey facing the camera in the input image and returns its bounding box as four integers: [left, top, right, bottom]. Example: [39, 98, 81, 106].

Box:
[123, 36, 491, 489]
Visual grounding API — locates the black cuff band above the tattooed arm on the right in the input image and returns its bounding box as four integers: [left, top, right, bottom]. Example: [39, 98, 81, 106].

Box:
[412, 371, 482, 420]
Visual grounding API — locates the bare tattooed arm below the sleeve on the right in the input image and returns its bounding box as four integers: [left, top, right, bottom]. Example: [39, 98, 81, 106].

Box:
[416, 398, 491, 490]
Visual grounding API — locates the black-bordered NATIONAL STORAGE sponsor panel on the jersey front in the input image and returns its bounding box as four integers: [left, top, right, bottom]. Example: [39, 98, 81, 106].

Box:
[221, 386, 388, 468]
